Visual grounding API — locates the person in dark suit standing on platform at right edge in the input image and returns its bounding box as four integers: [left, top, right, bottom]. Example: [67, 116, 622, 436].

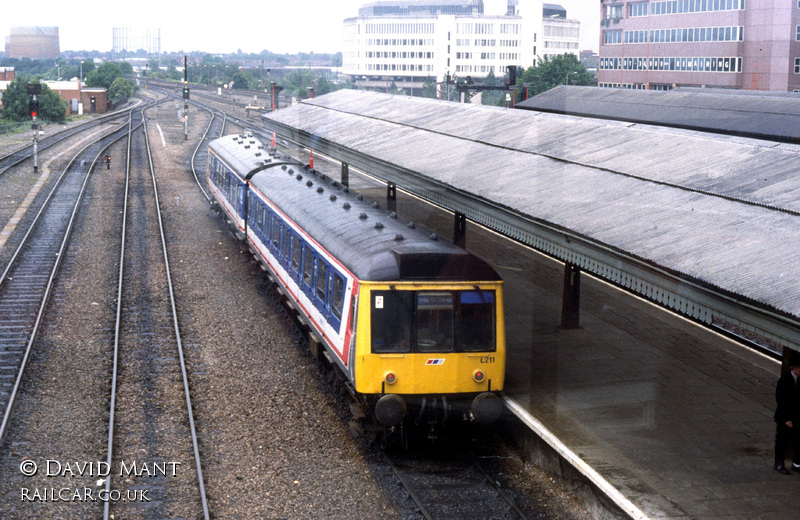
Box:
[775, 354, 800, 475]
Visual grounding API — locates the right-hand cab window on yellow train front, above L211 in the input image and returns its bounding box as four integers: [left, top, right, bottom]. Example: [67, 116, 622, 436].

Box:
[457, 291, 495, 352]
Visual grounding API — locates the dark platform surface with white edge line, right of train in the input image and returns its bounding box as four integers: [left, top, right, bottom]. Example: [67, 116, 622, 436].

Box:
[500, 246, 800, 520]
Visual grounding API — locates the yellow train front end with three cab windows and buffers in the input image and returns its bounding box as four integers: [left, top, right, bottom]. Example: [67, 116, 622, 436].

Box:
[354, 280, 505, 426]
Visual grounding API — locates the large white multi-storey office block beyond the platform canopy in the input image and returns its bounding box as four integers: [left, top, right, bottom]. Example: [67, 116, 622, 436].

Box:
[342, 0, 542, 91]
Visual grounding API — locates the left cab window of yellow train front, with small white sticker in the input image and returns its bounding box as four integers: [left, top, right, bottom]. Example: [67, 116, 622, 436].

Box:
[370, 291, 414, 354]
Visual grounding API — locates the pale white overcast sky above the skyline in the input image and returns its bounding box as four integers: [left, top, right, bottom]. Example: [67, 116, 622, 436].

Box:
[0, 0, 600, 54]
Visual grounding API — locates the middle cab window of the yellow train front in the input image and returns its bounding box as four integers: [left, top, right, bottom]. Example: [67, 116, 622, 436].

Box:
[416, 291, 455, 352]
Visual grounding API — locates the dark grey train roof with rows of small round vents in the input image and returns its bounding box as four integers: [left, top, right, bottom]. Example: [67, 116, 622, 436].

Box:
[212, 137, 500, 281]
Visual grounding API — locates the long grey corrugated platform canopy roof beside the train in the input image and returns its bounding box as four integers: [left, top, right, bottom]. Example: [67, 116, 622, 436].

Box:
[263, 90, 800, 350]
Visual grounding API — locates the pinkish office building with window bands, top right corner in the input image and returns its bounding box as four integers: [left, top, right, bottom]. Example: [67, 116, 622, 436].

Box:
[598, 0, 800, 91]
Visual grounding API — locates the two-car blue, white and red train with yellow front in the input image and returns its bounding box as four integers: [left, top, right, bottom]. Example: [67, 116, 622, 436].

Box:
[207, 134, 505, 429]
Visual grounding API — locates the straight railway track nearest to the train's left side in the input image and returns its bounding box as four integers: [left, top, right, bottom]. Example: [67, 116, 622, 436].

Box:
[103, 95, 210, 519]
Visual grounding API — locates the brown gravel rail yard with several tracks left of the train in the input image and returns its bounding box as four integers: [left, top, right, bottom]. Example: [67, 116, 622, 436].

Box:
[0, 87, 590, 520]
